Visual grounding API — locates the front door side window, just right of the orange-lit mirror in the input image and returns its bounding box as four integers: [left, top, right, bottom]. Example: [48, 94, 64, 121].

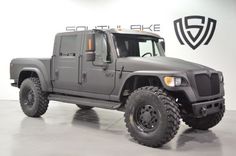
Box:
[95, 33, 110, 62]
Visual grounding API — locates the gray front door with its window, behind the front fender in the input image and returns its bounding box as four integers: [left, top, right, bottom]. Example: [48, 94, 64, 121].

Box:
[82, 31, 115, 98]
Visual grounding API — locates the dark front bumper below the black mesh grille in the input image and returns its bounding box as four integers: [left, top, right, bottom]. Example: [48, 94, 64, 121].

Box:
[192, 98, 225, 118]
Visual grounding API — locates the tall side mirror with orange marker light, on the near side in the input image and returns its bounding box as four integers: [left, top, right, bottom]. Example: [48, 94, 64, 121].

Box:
[86, 33, 95, 61]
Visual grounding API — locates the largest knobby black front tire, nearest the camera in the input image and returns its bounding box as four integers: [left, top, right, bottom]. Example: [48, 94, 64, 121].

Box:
[124, 86, 180, 147]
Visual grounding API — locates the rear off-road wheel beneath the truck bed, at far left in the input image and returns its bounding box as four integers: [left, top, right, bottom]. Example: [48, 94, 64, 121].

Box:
[19, 77, 49, 117]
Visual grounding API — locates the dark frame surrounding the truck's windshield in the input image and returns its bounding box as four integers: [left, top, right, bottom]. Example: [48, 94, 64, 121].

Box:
[112, 33, 165, 58]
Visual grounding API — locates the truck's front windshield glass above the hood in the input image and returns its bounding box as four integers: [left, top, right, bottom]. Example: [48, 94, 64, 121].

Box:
[114, 34, 164, 57]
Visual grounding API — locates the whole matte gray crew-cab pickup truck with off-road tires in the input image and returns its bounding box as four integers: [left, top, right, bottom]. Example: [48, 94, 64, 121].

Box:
[10, 29, 225, 147]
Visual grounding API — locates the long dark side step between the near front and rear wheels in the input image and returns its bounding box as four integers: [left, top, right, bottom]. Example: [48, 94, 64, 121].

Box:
[48, 94, 121, 109]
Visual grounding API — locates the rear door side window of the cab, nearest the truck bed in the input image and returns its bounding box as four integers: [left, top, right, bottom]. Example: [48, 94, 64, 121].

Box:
[59, 35, 78, 56]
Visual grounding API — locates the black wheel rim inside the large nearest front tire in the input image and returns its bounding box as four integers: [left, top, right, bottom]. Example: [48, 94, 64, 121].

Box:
[134, 104, 159, 132]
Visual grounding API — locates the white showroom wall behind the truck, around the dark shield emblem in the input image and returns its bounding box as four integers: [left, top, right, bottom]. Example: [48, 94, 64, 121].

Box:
[0, 0, 236, 109]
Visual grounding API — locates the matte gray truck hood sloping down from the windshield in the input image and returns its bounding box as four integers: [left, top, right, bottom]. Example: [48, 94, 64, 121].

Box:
[116, 56, 213, 72]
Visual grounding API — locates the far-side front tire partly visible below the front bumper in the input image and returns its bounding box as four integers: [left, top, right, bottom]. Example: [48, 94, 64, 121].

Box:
[183, 108, 225, 130]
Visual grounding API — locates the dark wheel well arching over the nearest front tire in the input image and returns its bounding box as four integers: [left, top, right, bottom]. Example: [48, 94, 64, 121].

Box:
[120, 75, 163, 104]
